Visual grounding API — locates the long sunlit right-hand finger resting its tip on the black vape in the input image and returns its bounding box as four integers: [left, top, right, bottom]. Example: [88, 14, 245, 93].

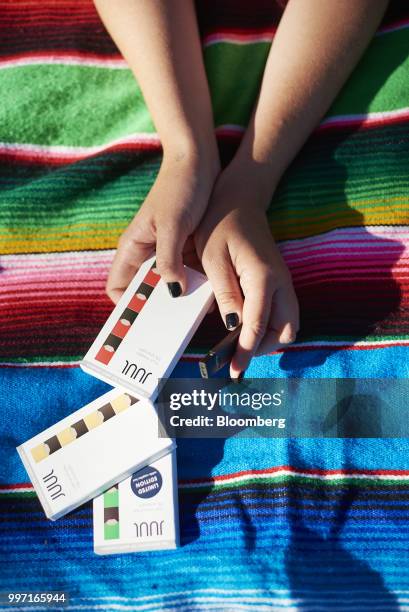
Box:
[230, 270, 273, 378]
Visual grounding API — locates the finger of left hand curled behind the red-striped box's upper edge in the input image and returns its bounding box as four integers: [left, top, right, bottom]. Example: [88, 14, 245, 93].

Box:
[105, 234, 154, 304]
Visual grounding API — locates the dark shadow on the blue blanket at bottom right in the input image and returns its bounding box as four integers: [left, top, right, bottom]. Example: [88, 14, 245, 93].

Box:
[285, 444, 400, 612]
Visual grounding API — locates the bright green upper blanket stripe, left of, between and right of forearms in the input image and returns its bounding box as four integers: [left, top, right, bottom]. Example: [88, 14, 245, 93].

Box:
[0, 29, 409, 146]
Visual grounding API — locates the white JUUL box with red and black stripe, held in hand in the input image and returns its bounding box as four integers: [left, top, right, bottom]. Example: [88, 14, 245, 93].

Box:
[81, 258, 213, 399]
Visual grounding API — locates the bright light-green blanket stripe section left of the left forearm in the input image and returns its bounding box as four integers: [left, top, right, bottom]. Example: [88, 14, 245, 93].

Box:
[0, 65, 154, 146]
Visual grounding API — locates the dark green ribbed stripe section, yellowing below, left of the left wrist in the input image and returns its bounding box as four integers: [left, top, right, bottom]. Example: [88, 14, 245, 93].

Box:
[0, 154, 160, 235]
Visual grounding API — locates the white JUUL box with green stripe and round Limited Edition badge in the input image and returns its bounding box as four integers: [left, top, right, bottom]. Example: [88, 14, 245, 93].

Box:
[94, 451, 179, 555]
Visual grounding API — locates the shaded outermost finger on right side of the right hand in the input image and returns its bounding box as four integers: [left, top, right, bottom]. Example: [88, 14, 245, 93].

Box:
[256, 285, 300, 355]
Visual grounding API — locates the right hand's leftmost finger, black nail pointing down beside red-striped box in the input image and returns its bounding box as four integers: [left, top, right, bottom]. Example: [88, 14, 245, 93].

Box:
[203, 253, 243, 331]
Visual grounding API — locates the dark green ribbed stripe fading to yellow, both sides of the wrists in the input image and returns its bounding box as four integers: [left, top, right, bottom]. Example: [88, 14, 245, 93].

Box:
[0, 126, 409, 238]
